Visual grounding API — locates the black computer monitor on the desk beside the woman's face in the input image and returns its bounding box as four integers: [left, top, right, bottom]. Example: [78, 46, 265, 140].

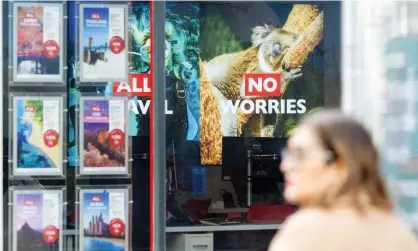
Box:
[222, 137, 287, 206]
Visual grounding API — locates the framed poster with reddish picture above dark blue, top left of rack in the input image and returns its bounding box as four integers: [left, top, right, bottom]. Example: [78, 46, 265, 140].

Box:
[13, 3, 63, 82]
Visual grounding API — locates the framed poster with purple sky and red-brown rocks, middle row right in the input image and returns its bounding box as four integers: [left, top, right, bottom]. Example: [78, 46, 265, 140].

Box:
[80, 97, 128, 175]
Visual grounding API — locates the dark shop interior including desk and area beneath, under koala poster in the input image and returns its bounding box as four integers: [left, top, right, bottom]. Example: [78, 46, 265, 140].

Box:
[166, 137, 296, 250]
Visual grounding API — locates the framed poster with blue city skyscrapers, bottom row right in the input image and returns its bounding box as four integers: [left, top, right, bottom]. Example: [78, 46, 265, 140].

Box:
[79, 189, 128, 251]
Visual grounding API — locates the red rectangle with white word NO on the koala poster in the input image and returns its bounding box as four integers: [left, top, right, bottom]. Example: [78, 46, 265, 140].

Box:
[244, 73, 281, 97]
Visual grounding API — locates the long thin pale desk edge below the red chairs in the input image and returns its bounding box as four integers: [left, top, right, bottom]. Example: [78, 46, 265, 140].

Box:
[165, 223, 281, 233]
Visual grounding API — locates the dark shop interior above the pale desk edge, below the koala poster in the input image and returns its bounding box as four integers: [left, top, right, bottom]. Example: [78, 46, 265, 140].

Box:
[167, 137, 294, 227]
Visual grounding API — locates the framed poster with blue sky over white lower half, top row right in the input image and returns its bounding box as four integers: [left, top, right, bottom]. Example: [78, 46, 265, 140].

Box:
[80, 5, 128, 82]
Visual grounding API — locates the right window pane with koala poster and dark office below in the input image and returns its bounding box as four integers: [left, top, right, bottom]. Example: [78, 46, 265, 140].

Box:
[164, 1, 341, 251]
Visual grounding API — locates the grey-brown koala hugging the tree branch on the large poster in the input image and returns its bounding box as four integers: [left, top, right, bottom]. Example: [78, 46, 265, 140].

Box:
[200, 25, 302, 141]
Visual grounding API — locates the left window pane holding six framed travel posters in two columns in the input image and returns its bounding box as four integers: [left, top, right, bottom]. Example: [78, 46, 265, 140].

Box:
[1, 0, 152, 251]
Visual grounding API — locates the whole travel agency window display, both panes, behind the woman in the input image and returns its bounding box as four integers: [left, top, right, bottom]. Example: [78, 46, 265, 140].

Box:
[0, 1, 339, 251]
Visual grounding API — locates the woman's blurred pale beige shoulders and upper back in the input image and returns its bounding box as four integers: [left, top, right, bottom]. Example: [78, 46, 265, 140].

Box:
[269, 208, 418, 251]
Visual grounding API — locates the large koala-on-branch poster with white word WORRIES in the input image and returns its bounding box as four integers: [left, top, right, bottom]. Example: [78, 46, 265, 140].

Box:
[199, 2, 330, 165]
